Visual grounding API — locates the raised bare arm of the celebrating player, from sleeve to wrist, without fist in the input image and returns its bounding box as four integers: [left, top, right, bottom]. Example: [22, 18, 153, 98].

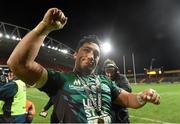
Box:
[7, 23, 46, 82]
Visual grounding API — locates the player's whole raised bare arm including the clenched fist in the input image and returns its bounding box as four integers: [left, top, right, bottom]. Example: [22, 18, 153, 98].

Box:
[7, 8, 67, 86]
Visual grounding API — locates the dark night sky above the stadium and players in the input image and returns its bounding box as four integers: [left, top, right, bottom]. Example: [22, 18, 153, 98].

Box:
[0, 0, 180, 73]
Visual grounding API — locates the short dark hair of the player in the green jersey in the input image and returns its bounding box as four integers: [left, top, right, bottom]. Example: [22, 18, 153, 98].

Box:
[76, 35, 101, 52]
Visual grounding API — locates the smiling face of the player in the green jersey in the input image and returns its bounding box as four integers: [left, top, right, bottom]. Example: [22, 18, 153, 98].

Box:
[74, 42, 100, 74]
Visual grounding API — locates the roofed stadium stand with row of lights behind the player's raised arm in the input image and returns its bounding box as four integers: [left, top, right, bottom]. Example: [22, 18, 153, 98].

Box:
[0, 22, 74, 71]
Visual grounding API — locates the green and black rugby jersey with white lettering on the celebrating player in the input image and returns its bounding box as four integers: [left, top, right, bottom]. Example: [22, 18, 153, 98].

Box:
[41, 69, 121, 123]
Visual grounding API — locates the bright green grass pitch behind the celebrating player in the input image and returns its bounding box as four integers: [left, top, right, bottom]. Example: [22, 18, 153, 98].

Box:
[27, 83, 180, 123]
